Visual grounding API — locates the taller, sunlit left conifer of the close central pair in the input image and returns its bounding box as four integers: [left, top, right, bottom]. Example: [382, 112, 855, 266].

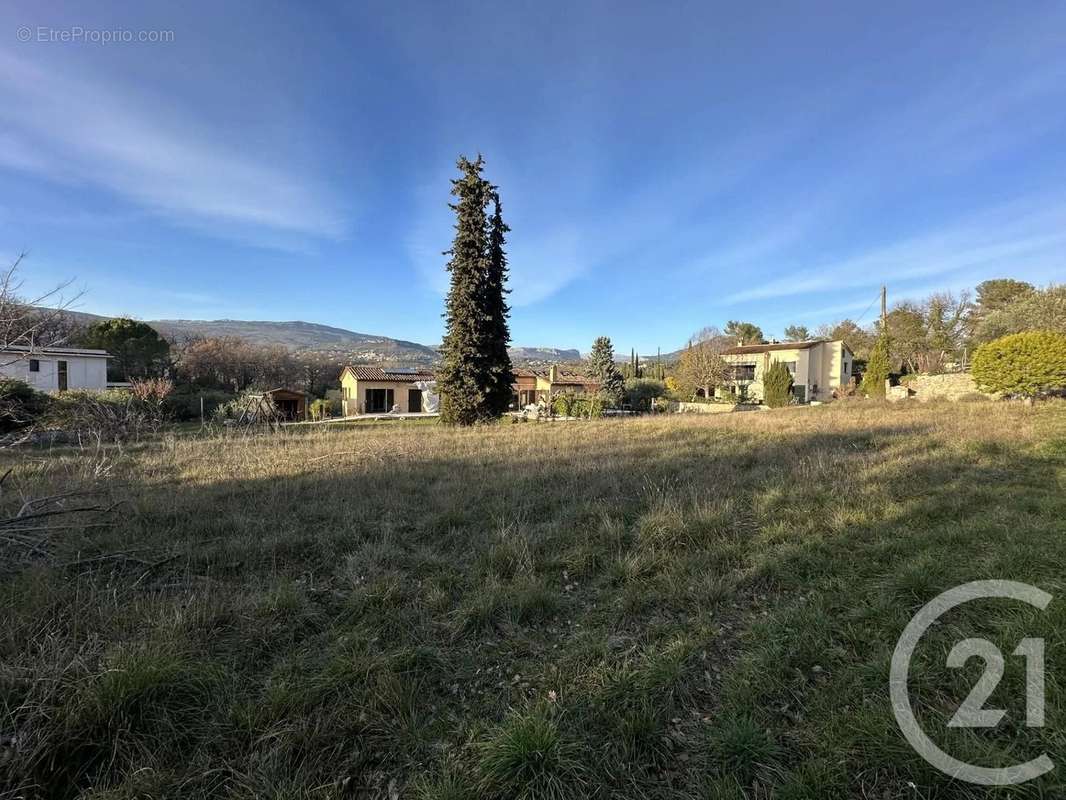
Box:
[437, 156, 490, 425]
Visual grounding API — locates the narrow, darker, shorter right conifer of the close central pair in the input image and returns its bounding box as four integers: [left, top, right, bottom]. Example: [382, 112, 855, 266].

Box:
[483, 187, 515, 417]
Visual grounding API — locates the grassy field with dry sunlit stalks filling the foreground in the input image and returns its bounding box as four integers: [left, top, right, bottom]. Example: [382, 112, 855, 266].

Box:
[0, 402, 1066, 800]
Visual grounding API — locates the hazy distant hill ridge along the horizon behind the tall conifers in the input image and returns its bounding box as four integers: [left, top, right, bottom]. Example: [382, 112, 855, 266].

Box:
[55, 311, 581, 365]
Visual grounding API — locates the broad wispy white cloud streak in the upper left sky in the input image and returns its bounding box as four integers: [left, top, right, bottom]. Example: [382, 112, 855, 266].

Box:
[0, 51, 345, 244]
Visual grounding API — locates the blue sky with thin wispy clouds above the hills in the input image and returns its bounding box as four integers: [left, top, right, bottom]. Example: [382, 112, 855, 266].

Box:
[0, 1, 1066, 352]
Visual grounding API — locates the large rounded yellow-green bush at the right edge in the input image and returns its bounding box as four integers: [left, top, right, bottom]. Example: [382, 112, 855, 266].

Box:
[971, 331, 1066, 397]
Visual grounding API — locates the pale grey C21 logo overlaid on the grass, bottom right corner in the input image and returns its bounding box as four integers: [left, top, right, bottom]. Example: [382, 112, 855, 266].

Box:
[889, 580, 1055, 786]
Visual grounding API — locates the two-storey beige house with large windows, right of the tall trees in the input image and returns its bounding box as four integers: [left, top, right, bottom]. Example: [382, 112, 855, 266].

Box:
[715, 339, 855, 402]
